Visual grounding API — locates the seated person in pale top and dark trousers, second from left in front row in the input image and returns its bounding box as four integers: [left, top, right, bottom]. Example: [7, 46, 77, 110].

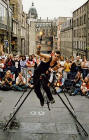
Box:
[13, 72, 28, 91]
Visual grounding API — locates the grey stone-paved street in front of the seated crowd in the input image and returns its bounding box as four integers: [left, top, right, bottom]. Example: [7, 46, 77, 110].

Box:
[0, 91, 89, 140]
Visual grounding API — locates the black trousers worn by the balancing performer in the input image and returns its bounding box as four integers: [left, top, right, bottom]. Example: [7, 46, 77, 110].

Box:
[33, 73, 53, 102]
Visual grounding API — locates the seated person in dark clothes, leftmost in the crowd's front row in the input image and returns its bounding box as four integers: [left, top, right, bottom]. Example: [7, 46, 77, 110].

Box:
[0, 70, 12, 91]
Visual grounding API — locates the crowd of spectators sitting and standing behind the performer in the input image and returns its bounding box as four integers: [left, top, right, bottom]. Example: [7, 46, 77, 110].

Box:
[0, 54, 89, 96]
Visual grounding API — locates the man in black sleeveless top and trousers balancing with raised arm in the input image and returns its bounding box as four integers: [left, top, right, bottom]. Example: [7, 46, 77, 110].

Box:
[33, 46, 60, 106]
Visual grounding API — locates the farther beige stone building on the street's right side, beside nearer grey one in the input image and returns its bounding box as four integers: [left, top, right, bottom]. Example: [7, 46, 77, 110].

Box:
[60, 18, 73, 57]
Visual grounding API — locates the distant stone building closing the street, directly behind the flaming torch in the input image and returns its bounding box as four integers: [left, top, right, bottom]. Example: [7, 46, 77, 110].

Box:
[36, 18, 57, 53]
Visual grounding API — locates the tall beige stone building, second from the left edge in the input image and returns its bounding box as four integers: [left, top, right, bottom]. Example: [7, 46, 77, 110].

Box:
[10, 0, 29, 55]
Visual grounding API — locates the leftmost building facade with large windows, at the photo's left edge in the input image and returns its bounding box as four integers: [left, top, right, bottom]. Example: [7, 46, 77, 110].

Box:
[0, 0, 12, 54]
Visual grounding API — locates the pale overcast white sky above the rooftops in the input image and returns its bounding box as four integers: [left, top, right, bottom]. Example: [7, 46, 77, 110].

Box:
[22, 0, 88, 19]
